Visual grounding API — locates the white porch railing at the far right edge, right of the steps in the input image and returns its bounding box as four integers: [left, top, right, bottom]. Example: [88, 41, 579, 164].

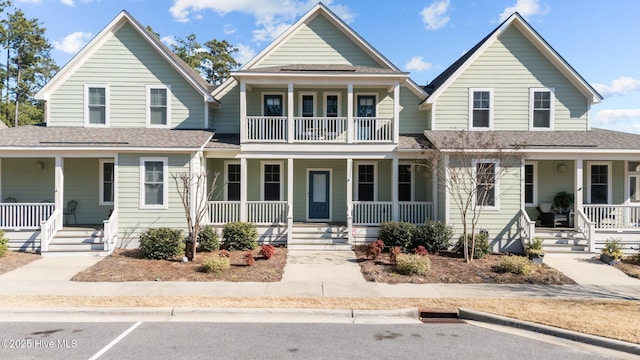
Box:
[584, 204, 640, 230]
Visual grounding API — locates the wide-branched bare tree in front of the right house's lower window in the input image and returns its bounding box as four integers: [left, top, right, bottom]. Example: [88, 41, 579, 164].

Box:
[424, 130, 523, 262]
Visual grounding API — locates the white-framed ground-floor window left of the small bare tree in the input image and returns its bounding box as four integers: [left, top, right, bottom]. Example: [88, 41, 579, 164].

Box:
[140, 158, 168, 209]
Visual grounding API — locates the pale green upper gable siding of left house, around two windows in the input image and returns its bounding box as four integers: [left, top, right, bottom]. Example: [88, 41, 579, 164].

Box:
[47, 24, 205, 129]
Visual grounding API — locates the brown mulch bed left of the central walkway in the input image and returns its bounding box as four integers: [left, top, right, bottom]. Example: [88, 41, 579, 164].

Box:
[72, 247, 287, 282]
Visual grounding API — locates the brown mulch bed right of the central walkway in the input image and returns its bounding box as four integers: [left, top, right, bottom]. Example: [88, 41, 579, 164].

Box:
[356, 246, 575, 285]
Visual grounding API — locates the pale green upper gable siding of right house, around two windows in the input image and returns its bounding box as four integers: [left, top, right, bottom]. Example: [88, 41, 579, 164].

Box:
[436, 27, 589, 130]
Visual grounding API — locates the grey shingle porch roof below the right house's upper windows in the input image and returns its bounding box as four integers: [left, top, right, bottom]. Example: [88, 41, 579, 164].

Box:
[424, 128, 640, 151]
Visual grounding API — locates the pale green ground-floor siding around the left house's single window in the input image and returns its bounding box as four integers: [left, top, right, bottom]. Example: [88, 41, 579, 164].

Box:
[117, 153, 190, 243]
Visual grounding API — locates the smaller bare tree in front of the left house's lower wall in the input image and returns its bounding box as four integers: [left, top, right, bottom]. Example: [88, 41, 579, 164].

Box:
[171, 171, 220, 261]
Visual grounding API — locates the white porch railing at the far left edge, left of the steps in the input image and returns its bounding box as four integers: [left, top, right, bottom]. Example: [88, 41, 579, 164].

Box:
[0, 203, 55, 230]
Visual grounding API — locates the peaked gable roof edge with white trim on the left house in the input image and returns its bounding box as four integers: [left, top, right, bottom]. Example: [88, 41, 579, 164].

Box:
[35, 10, 219, 104]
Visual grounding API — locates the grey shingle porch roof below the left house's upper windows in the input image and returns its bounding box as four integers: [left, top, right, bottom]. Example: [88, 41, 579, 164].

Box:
[0, 126, 213, 149]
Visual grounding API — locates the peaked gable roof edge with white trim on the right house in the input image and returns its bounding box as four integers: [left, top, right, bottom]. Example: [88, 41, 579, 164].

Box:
[423, 12, 603, 104]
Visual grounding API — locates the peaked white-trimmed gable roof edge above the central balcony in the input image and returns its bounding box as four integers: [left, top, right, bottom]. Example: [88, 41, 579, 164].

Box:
[212, 2, 427, 98]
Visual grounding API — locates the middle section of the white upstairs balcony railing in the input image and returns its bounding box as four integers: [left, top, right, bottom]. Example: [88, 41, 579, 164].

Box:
[293, 117, 347, 143]
